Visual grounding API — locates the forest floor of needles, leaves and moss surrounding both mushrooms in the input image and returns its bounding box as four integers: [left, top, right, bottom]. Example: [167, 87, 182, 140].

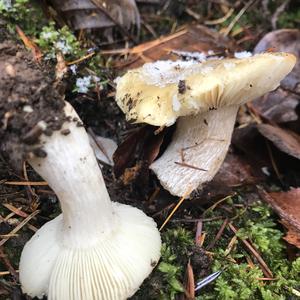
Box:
[0, 0, 300, 300]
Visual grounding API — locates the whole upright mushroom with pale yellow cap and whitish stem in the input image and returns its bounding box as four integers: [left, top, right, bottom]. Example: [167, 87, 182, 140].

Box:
[116, 53, 296, 196]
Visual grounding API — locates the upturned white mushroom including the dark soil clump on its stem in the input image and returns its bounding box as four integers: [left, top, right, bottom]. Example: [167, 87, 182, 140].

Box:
[0, 41, 161, 300]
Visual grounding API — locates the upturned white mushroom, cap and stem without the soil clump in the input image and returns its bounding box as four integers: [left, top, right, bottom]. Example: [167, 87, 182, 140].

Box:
[20, 104, 161, 300]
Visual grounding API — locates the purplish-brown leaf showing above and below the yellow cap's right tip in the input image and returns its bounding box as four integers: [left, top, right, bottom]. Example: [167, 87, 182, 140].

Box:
[250, 29, 300, 123]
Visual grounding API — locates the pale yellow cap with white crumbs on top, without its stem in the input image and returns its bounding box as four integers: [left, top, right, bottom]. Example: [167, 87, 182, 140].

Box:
[116, 53, 296, 126]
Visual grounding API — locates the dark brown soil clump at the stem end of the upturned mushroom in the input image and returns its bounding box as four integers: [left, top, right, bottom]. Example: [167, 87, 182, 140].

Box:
[0, 41, 65, 169]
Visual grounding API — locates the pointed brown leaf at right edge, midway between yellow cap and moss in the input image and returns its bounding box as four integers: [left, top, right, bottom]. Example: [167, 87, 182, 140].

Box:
[257, 124, 300, 159]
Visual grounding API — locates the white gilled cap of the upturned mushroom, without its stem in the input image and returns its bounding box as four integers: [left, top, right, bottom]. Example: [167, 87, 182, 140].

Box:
[20, 203, 161, 300]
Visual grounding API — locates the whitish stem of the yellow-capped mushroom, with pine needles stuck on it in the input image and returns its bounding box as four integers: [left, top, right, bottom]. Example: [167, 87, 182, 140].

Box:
[150, 105, 238, 196]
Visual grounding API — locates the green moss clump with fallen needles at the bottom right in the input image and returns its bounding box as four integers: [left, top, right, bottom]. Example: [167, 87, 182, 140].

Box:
[133, 196, 300, 300]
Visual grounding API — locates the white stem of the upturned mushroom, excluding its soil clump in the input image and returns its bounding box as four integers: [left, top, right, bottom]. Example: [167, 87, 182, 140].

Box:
[28, 106, 116, 247]
